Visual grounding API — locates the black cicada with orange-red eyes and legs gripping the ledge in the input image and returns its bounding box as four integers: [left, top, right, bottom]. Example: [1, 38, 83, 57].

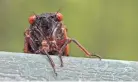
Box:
[24, 12, 101, 74]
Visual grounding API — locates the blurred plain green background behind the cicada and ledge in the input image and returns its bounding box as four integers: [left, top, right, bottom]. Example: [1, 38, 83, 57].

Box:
[0, 0, 138, 61]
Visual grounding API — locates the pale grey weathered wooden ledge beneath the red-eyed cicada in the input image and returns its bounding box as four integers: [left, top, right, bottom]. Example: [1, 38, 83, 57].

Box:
[0, 52, 138, 81]
